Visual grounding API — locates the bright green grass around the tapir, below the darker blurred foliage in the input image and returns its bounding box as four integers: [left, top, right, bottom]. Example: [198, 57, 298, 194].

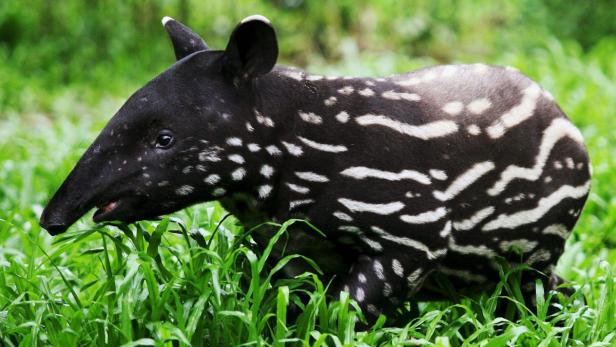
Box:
[0, 17, 616, 346]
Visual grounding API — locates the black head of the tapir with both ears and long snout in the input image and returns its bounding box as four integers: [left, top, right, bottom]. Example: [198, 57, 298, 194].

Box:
[40, 16, 278, 235]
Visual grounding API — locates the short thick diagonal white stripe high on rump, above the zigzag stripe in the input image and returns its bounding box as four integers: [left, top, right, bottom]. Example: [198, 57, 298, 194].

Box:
[486, 83, 541, 139]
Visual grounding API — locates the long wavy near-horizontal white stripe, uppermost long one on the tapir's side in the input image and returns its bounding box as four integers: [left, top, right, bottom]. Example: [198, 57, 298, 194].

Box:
[355, 114, 458, 140]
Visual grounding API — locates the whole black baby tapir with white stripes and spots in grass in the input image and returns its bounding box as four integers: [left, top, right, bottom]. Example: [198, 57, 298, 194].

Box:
[40, 16, 590, 322]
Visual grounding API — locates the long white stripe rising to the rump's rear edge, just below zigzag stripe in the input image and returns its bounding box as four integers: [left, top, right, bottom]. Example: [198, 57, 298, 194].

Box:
[482, 181, 590, 231]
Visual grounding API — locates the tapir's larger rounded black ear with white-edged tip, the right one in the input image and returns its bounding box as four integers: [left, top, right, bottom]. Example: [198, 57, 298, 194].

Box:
[223, 15, 278, 80]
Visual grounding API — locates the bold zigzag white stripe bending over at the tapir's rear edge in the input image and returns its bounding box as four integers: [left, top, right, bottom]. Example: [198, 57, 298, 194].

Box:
[488, 118, 584, 196]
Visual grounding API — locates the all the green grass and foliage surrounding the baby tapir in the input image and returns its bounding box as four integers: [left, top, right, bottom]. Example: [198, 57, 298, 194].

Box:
[0, 0, 616, 346]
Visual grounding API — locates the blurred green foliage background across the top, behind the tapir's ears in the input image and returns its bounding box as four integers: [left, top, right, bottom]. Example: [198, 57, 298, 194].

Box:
[0, 0, 616, 110]
